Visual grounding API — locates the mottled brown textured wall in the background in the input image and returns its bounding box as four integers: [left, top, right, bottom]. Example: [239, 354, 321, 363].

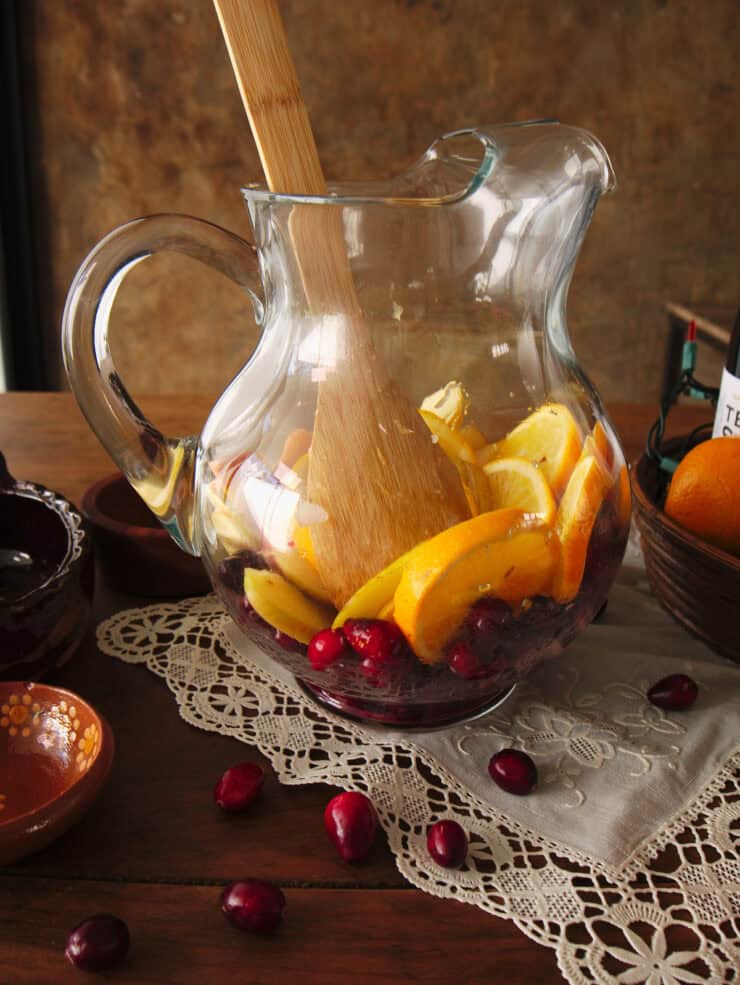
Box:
[24, 0, 740, 399]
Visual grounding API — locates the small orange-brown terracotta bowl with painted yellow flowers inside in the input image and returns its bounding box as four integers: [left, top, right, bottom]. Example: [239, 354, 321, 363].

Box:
[0, 681, 113, 865]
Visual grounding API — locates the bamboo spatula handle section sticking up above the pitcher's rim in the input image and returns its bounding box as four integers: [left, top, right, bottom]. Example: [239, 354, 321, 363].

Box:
[214, 0, 326, 195]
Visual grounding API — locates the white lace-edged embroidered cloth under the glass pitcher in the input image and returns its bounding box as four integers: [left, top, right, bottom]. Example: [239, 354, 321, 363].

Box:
[98, 540, 740, 985]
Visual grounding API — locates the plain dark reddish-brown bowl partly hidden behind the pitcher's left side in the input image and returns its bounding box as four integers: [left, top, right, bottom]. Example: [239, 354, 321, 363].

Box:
[82, 472, 211, 598]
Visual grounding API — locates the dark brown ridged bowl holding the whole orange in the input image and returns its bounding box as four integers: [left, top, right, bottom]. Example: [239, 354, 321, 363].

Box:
[632, 438, 740, 663]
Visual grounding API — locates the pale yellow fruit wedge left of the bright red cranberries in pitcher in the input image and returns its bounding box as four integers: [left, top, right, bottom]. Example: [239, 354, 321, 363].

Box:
[244, 568, 334, 643]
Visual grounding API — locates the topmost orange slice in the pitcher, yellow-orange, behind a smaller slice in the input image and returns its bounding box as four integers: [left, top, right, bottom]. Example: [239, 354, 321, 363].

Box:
[478, 403, 582, 499]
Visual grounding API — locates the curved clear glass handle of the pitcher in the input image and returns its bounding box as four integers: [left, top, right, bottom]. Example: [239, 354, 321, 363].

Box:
[62, 215, 263, 554]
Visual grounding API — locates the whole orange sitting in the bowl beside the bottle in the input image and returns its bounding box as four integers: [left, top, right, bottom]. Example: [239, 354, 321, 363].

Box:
[665, 437, 740, 555]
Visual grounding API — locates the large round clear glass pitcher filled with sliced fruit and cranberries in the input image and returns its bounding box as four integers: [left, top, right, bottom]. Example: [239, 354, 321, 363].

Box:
[63, 121, 631, 728]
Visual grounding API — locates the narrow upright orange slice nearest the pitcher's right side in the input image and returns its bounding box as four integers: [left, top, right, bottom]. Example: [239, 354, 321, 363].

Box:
[552, 455, 609, 602]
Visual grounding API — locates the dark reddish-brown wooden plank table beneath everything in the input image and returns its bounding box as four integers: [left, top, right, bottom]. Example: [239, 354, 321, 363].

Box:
[0, 394, 706, 985]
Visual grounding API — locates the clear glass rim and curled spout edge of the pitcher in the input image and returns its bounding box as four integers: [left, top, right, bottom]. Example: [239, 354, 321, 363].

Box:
[240, 117, 614, 208]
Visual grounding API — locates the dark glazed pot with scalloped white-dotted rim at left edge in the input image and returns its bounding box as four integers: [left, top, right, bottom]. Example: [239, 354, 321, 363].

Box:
[0, 454, 93, 680]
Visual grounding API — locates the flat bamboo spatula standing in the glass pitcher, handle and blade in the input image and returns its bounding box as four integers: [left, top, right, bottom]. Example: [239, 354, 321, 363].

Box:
[214, 0, 470, 607]
